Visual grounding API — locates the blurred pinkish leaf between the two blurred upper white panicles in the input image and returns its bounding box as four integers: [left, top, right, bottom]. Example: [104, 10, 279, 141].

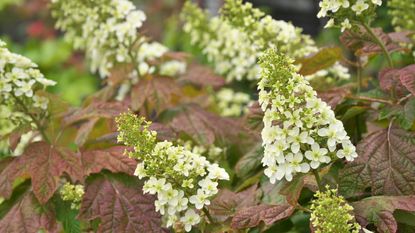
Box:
[179, 63, 225, 88]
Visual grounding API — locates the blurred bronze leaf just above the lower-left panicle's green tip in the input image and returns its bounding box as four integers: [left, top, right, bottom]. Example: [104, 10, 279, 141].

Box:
[131, 77, 181, 114]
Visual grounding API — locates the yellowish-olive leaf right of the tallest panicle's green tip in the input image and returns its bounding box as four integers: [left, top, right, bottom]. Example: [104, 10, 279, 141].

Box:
[297, 47, 343, 75]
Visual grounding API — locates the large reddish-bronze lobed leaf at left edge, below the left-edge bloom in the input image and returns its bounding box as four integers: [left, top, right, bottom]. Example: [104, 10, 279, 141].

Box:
[0, 142, 83, 204]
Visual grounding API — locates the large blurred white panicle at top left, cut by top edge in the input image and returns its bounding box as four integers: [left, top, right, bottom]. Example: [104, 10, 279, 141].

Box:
[52, 0, 187, 78]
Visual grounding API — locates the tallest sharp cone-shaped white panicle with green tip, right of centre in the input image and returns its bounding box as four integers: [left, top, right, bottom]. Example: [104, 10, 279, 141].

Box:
[258, 49, 357, 183]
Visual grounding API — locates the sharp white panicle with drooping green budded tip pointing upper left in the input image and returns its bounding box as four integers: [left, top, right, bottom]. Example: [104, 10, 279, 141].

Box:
[117, 113, 229, 231]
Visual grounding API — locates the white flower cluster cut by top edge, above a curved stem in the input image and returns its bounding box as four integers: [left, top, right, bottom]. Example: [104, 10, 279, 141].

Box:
[317, 0, 382, 32]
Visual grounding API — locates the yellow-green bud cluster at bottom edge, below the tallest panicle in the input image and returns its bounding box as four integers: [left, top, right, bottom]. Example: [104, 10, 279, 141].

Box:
[310, 186, 360, 233]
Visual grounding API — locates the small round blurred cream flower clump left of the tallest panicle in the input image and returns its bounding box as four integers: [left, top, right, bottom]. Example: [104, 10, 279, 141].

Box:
[214, 88, 251, 117]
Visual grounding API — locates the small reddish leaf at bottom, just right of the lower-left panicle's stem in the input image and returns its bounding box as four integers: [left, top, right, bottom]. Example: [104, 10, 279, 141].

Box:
[208, 185, 257, 222]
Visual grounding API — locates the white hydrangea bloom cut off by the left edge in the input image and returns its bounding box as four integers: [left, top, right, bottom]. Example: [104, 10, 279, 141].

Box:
[0, 41, 55, 131]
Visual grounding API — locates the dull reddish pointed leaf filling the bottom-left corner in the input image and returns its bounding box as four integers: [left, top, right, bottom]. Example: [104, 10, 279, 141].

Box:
[0, 193, 59, 233]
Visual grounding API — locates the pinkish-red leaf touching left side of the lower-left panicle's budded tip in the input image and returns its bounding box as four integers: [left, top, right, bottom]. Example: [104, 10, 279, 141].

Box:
[81, 146, 137, 176]
